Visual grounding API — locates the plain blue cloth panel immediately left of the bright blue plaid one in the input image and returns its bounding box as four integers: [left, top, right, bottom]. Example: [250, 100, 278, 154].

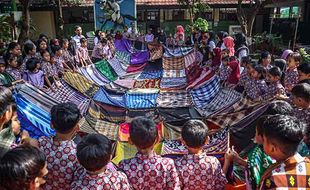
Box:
[94, 87, 126, 107]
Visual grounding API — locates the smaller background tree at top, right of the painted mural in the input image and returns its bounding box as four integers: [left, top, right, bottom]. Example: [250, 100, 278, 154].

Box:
[178, 0, 209, 25]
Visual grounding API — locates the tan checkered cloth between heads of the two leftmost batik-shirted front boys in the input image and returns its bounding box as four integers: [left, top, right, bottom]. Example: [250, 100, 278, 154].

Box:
[79, 115, 119, 141]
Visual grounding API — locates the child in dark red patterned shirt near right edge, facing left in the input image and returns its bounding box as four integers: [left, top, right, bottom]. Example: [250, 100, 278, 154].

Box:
[284, 52, 301, 93]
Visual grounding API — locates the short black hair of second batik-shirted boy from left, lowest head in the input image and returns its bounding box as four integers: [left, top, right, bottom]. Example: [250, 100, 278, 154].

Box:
[76, 134, 112, 172]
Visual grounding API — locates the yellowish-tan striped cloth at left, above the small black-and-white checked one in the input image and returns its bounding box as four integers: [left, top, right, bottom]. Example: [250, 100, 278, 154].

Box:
[64, 72, 99, 97]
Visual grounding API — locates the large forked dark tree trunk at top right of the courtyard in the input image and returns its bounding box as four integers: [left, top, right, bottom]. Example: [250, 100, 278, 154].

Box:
[237, 0, 272, 37]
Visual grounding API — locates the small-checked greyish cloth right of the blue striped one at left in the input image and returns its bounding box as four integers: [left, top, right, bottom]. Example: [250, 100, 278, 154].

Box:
[46, 80, 90, 115]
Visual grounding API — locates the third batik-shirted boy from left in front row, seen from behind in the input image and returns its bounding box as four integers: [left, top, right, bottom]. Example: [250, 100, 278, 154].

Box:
[119, 117, 180, 190]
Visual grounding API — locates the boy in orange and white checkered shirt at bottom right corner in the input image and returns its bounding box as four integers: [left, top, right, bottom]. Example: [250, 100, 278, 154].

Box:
[259, 115, 310, 190]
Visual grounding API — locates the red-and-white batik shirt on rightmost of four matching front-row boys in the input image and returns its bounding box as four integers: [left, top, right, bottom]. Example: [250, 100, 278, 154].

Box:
[175, 153, 227, 190]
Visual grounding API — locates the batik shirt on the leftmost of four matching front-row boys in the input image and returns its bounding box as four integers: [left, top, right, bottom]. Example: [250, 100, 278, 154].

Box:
[39, 137, 81, 190]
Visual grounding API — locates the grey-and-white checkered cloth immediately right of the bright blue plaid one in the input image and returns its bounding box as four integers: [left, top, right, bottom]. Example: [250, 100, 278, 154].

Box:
[157, 90, 193, 108]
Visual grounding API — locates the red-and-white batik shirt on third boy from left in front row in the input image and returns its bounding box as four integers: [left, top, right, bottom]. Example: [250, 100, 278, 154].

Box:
[119, 153, 180, 190]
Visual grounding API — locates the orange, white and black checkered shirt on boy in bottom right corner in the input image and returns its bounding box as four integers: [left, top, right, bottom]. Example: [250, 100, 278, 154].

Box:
[259, 153, 310, 190]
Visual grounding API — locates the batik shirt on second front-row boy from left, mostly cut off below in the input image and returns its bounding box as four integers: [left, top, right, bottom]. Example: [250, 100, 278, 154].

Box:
[71, 169, 130, 190]
